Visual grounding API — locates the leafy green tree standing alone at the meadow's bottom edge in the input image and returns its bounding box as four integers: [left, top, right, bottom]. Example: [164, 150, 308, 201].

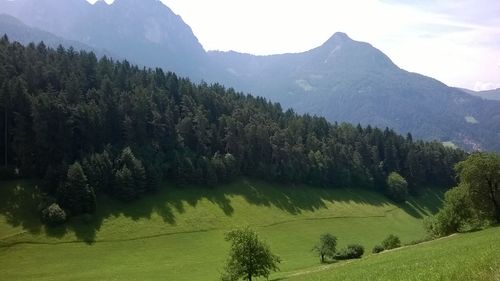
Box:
[221, 227, 281, 281]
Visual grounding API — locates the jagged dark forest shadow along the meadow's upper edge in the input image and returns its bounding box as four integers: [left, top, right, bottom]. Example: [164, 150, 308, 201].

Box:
[0, 179, 442, 244]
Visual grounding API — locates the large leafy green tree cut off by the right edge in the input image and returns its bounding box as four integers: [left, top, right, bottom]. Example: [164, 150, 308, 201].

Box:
[455, 153, 500, 223]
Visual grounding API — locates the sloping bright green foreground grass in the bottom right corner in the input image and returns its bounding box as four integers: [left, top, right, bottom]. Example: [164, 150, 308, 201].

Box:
[280, 227, 500, 281]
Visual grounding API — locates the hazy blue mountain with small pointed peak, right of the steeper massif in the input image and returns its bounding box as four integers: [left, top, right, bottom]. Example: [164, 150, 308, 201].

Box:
[209, 33, 500, 149]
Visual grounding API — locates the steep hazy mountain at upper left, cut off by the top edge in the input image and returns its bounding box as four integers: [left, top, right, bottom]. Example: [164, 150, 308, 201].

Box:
[0, 0, 206, 79]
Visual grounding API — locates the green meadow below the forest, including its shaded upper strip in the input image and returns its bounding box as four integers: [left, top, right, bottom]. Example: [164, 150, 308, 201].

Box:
[0, 180, 446, 280]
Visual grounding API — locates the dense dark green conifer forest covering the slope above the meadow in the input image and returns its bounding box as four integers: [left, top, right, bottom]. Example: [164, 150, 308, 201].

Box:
[0, 36, 465, 217]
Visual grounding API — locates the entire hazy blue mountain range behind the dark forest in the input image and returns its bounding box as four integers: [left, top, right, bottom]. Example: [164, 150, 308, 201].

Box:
[0, 0, 500, 151]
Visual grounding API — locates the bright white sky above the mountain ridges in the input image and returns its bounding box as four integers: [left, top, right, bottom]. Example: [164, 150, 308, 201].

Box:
[88, 0, 500, 90]
